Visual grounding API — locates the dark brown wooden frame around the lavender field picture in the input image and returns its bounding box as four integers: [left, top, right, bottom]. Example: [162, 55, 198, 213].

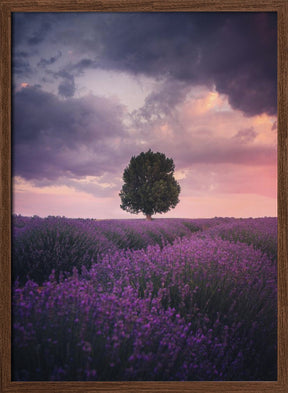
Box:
[0, 0, 288, 393]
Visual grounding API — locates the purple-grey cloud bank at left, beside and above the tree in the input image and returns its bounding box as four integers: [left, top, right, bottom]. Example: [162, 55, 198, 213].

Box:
[12, 87, 126, 180]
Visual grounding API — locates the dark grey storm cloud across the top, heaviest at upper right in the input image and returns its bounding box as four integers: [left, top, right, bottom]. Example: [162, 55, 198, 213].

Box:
[13, 12, 277, 116]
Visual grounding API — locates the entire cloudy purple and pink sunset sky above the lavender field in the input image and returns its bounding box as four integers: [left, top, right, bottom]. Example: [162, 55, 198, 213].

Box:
[12, 12, 277, 218]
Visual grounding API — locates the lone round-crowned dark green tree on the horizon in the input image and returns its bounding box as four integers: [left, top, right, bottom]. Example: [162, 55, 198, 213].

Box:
[119, 149, 180, 220]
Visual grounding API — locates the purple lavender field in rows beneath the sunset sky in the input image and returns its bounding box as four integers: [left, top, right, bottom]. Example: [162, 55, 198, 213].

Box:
[12, 216, 277, 381]
